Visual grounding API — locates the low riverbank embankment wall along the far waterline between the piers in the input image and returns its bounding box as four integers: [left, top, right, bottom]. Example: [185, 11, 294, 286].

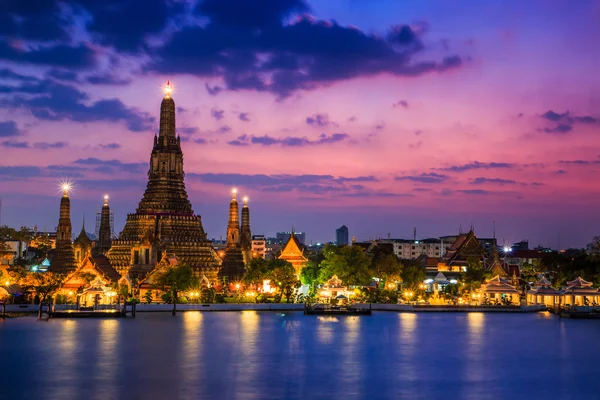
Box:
[6, 303, 546, 313]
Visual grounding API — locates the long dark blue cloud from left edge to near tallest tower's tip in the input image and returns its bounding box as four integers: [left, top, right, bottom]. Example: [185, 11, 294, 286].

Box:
[0, 80, 155, 132]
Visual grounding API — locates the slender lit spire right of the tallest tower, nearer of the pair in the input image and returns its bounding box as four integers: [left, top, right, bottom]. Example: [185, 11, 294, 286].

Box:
[219, 189, 246, 283]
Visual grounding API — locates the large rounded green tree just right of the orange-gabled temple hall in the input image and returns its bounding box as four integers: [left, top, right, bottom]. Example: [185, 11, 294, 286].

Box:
[319, 245, 371, 285]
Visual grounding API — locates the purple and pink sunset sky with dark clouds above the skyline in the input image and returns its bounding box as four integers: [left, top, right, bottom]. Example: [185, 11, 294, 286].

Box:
[0, 0, 600, 248]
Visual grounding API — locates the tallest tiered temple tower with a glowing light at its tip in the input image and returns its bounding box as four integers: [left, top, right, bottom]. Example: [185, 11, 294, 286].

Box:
[107, 83, 218, 281]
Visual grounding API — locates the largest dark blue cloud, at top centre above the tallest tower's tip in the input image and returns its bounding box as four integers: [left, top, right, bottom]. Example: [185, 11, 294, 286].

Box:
[148, 0, 462, 98]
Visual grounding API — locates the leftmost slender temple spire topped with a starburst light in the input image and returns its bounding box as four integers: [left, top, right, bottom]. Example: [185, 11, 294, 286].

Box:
[48, 183, 77, 274]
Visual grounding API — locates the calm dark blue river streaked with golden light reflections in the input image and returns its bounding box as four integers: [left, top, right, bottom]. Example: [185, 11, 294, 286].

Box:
[0, 311, 600, 400]
